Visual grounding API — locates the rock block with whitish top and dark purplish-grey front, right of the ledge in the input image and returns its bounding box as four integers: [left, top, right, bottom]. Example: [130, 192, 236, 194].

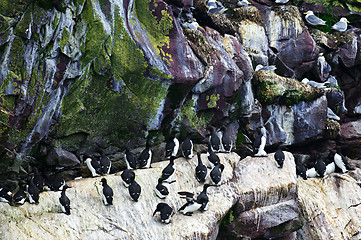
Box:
[229, 153, 300, 238]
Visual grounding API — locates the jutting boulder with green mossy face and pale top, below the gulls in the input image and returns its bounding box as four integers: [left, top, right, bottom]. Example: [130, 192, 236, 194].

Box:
[252, 71, 323, 106]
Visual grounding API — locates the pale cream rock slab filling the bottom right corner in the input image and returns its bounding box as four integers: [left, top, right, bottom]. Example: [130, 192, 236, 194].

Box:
[298, 169, 361, 240]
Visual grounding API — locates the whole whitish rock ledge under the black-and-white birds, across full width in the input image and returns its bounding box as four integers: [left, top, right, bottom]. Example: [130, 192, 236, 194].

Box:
[0, 152, 361, 240]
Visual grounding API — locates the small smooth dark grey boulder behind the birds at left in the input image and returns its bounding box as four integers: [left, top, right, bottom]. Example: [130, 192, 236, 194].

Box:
[46, 148, 80, 167]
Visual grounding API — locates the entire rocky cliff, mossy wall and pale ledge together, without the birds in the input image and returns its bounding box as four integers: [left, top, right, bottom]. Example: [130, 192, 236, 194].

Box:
[0, 0, 361, 240]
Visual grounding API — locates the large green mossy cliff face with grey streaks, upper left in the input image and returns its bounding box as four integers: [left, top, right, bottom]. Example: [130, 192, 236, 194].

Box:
[0, 0, 201, 170]
